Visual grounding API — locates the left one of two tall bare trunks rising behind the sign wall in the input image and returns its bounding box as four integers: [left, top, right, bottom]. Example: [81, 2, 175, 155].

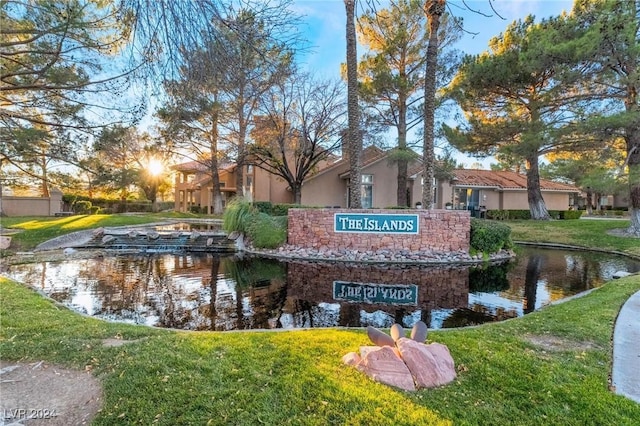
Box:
[344, 0, 362, 209]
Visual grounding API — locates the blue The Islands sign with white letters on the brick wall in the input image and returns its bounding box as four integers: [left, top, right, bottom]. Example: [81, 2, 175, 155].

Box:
[333, 213, 419, 234]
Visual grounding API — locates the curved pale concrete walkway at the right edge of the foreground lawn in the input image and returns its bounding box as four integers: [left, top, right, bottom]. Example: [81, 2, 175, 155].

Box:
[611, 291, 640, 404]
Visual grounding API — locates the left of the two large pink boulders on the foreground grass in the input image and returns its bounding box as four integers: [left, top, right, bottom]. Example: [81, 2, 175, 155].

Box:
[356, 346, 416, 391]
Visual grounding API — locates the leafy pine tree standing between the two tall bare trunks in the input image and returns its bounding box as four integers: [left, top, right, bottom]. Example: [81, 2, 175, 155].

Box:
[358, 0, 460, 206]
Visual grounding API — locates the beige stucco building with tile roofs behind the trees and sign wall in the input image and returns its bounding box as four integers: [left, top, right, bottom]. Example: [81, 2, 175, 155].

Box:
[174, 147, 580, 215]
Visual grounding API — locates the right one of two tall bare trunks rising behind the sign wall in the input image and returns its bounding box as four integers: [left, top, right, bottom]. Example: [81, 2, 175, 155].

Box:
[422, 0, 447, 209]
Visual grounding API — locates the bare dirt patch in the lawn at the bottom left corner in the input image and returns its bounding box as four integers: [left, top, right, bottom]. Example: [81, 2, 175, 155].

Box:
[0, 361, 102, 426]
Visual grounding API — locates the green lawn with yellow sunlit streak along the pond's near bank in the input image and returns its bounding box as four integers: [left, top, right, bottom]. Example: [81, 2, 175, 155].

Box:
[0, 221, 640, 425]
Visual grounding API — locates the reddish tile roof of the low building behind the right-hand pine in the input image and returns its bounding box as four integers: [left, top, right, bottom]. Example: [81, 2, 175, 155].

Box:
[453, 169, 580, 192]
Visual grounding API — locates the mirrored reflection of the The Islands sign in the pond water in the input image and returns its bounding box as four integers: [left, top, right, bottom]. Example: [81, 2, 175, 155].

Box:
[333, 281, 418, 305]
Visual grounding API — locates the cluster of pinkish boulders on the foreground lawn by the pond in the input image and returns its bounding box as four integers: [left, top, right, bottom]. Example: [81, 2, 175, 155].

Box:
[342, 321, 456, 391]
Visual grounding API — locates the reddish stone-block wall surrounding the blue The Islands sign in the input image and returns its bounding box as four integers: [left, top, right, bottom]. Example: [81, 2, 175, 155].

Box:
[287, 209, 471, 252]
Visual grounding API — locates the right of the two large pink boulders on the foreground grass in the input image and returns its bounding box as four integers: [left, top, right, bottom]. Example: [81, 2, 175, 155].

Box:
[396, 338, 456, 389]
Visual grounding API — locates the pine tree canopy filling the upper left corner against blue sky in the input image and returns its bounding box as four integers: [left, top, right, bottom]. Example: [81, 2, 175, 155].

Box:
[0, 0, 138, 195]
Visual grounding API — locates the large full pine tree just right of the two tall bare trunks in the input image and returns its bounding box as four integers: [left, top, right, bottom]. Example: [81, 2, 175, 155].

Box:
[445, 16, 588, 219]
